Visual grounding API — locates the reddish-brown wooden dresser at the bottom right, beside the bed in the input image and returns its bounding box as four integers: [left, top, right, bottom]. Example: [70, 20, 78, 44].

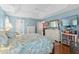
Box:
[54, 42, 71, 54]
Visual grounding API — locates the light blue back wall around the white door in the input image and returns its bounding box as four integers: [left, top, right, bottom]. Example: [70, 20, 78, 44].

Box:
[9, 16, 38, 33]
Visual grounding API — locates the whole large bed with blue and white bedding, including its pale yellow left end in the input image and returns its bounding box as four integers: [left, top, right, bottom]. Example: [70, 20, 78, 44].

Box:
[0, 33, 53, 54]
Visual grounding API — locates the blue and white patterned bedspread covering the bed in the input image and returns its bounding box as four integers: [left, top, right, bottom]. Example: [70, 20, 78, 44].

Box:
[0, 34, 53, 54]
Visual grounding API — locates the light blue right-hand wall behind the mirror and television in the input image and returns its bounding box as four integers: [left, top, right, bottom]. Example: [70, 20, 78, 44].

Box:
[44, 8, 79, 29]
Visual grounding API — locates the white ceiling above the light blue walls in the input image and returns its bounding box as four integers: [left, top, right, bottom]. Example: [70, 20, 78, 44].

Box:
[0, 4, 79, 19]
